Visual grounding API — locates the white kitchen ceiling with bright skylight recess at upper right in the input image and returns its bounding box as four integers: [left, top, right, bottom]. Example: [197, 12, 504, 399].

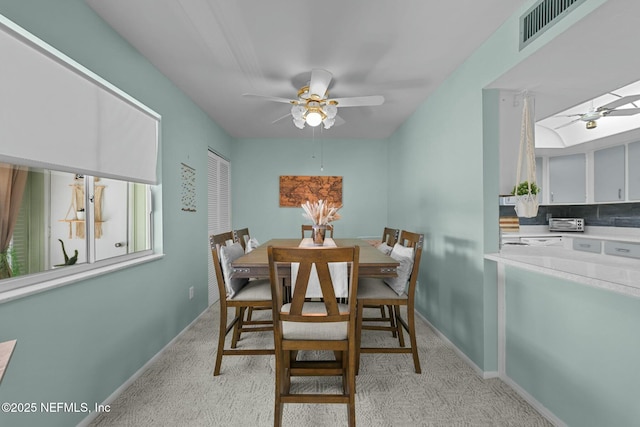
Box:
[490, 0, 640, 146]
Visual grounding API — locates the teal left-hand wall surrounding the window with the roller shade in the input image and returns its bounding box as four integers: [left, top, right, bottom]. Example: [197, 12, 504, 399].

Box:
[0, 0, 231, 427]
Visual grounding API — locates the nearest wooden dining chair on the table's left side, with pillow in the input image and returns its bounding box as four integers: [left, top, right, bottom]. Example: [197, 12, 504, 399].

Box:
[209, 231, 274, 376]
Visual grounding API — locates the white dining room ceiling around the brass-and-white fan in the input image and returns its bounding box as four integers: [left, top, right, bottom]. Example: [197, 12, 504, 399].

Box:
[86, 0, 524, 138]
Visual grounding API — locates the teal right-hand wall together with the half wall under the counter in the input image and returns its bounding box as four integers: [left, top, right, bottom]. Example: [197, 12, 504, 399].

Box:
[389, 1, 640, 426]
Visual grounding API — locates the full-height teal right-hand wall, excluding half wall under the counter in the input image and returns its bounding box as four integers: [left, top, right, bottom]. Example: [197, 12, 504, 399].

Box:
[389, 0, 603, 371]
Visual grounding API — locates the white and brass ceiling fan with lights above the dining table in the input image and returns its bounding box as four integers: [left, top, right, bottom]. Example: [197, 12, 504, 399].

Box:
[242, 68, 384, 129]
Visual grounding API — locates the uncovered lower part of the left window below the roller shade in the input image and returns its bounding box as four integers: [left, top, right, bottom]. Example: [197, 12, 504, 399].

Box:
[0, 164, 152, 292]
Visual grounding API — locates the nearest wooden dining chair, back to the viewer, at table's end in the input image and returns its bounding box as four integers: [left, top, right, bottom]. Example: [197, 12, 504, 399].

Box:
[267, 246, 360, 426]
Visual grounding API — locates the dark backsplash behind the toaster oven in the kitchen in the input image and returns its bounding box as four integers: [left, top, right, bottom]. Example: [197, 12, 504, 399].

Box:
[500, 203, 640, 228]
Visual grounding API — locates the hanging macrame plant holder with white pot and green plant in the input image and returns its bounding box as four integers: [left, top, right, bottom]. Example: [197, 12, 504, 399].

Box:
[513, 92, 540, 218]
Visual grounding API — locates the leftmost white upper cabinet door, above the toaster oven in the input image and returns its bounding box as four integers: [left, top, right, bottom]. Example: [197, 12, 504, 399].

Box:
[549, 154, 587, 203]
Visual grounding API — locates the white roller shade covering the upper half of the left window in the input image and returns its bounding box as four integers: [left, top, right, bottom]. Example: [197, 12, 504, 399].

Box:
[0, 16, 160, 184]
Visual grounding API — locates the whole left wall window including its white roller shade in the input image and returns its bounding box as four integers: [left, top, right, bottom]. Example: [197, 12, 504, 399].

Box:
[0, 15, 160, 300]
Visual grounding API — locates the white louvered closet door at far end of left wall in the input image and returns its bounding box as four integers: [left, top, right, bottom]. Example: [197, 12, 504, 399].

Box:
[206, 151, 231, 305]
